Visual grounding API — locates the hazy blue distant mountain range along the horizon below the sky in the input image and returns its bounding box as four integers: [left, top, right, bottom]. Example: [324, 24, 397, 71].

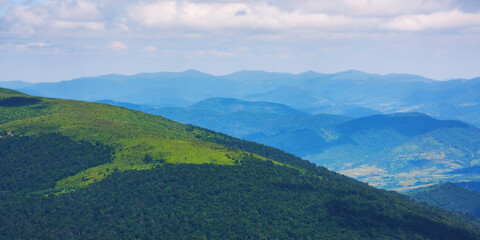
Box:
[0, 70, 480, 126]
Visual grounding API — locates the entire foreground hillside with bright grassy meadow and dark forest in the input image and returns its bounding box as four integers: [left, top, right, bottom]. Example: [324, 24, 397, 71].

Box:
[0, 89, 480, 239]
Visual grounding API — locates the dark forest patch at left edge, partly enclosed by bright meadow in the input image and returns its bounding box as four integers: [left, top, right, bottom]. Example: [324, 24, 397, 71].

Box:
[0, 133, 112, 192]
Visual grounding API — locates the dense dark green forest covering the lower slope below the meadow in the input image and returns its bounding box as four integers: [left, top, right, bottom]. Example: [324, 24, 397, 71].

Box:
[0, 158, 480, 239]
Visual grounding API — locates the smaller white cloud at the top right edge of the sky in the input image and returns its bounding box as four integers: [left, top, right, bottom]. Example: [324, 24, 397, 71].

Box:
[382, 9, 480, 31]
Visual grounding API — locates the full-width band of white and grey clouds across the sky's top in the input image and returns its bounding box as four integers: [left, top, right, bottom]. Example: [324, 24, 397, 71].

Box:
[1, 0, 480, 37]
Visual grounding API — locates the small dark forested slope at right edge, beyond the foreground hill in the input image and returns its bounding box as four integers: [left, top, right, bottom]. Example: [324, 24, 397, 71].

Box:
[407, 183, 480, 217]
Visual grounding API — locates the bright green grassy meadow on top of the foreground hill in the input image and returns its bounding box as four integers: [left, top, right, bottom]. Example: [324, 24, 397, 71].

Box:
[0, 90, 281, 191]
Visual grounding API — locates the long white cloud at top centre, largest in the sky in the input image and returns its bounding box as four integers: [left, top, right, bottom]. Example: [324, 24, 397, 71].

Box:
[127, 1, 378, 30]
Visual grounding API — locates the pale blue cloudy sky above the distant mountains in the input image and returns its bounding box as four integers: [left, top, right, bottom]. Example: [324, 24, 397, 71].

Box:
[0, 0, 480, 82]
